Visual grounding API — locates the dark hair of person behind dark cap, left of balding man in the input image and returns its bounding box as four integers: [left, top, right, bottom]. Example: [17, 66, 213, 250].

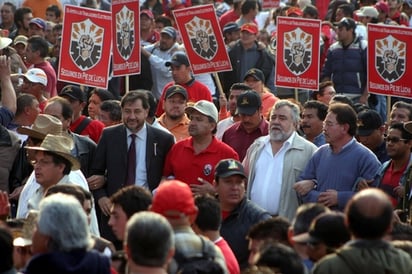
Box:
[292, 203, 329, 235]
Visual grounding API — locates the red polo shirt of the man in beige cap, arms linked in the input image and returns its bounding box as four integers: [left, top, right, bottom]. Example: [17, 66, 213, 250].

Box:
[163, 137, 239, 185]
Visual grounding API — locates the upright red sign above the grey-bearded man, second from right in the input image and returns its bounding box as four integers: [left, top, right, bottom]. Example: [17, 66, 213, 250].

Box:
[275, 17, 321, 90]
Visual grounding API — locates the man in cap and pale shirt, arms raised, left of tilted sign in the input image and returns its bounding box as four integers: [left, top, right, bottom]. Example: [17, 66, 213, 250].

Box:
[142, 27, 179, 100]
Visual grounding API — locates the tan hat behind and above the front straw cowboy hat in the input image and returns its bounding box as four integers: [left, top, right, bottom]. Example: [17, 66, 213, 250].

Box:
[17, 114, 62, 140]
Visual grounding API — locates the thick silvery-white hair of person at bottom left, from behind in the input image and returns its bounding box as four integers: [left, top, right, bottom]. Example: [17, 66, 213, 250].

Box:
[37, 193, 91, 252]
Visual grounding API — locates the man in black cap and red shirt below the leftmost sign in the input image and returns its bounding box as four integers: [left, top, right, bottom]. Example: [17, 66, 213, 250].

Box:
[59, 85, 104, 143]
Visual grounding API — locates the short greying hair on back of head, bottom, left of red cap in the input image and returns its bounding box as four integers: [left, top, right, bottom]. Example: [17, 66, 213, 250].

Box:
[125, 211, 174, 267]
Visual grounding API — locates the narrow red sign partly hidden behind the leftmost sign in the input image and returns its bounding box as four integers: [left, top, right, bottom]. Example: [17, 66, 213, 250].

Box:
[112, 0, 140, 76]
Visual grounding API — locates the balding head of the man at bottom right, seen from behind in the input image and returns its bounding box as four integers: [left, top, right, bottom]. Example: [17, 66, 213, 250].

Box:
[345, 188, 393, 240]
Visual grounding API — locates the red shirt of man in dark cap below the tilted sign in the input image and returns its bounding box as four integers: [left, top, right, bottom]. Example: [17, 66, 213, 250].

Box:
[156, 79, 213, 117]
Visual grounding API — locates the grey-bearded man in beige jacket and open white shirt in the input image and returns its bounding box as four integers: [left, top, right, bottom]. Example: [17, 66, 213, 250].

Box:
[243, 100, 316, 221]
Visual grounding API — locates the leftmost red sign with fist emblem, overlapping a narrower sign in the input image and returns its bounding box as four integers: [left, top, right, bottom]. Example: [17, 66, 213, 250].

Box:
[58, 5, 111, 88]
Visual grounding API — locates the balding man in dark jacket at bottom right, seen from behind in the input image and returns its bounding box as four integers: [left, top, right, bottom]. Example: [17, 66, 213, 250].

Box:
[313, 188, 412, 274]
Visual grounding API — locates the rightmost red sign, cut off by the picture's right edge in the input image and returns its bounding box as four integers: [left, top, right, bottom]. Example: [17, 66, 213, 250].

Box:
[368, 24, 412, 98]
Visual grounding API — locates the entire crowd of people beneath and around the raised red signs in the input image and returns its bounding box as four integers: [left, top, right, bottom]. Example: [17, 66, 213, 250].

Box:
[0, 0, 412, 274]
